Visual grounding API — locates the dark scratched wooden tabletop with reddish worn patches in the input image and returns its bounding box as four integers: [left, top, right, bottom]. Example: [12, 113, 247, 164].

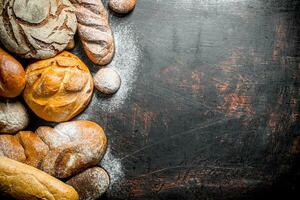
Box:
[30, 0, 300, 200]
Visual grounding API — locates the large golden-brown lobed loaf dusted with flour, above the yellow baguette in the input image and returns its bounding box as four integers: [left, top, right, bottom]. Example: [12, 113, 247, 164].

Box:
[0, 120, 107, 178]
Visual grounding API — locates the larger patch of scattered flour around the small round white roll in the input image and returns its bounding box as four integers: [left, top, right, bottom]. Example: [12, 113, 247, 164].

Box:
[80, 23, 141, 114]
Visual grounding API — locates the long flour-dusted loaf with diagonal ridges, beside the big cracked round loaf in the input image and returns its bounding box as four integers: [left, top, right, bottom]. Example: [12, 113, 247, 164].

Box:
[71, 0, 115, 65]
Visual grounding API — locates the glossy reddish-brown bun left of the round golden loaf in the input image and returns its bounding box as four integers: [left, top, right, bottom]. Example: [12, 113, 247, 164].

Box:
[0, 48, 25, 97]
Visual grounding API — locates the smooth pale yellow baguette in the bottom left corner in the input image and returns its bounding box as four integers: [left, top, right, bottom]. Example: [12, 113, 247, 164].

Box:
[0, 157, 78, 200]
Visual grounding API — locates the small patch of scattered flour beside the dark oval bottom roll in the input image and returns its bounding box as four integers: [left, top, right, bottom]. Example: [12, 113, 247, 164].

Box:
[100, 146, 124, 188]
